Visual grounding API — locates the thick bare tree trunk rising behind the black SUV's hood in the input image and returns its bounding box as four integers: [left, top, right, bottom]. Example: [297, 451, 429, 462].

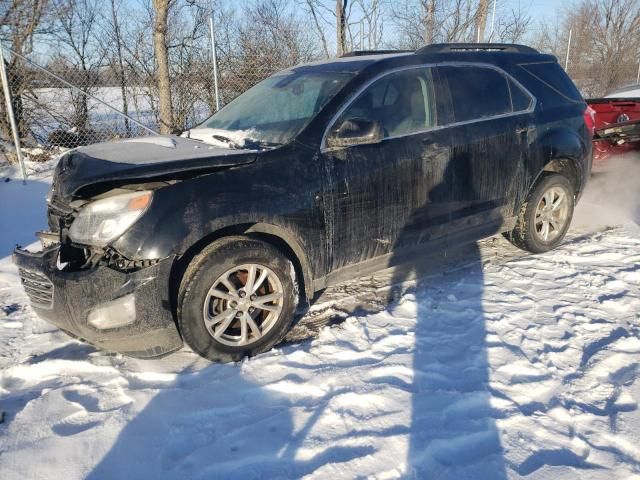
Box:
[153, 0, 173, 134]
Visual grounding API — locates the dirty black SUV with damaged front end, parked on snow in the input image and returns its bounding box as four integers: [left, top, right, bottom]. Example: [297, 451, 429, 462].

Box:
[14, 44, 591, 361]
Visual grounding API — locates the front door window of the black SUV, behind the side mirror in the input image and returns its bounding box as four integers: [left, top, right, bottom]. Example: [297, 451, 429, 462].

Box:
[332, 68, 436, 138]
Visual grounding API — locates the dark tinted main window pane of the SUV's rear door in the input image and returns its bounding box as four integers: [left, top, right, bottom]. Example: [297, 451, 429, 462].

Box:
[438, 66, 513, 122]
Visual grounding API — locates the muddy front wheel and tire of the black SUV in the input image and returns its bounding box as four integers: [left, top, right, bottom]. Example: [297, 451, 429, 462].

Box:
[177, 236, 298, 363]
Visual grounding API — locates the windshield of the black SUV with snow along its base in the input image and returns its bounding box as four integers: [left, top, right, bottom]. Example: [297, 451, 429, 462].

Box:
[189, 72, 352, 148]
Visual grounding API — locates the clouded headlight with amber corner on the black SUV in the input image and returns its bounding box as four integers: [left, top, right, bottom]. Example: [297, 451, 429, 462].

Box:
[69, 192, 153, 247]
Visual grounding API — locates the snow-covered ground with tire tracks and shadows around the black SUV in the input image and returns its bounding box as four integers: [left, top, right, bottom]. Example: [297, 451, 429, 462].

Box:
[0, 156, 640, 480]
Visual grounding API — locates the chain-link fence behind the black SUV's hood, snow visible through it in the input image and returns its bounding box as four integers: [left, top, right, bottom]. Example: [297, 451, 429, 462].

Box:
[0, 49, 258, 161]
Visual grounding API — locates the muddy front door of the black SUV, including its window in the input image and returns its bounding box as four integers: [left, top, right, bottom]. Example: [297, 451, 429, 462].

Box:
[322, 67, 452, 270]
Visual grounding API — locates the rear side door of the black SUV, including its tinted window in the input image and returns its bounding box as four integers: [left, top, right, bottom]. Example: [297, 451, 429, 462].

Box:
[437, 65, 535, 231]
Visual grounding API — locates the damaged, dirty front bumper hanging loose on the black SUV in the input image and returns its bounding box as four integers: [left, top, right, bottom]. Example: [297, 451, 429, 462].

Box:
[13, 242, 182, 358]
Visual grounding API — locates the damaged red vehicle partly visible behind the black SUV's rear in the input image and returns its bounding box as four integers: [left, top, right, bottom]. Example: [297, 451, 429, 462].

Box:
[587, 85, 640, 171]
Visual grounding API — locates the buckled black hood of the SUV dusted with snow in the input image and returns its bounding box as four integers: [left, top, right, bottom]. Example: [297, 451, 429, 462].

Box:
[54, 135, 258, 199]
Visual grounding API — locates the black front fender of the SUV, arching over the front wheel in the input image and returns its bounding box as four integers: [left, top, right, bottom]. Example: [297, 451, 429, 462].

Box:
[113, 160, 326, 294]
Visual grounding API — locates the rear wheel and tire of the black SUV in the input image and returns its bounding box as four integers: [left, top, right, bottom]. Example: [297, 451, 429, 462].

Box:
[505, 173, 575, 253]
